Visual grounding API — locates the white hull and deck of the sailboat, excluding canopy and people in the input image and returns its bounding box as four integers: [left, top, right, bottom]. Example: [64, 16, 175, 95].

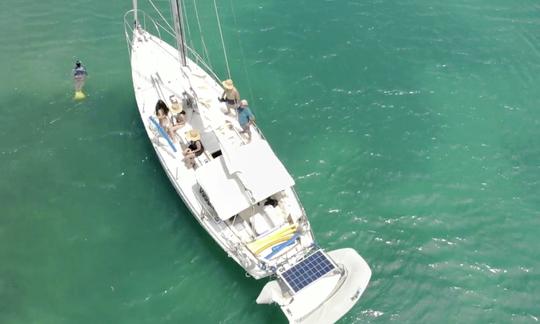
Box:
[131, 30, 313, 279]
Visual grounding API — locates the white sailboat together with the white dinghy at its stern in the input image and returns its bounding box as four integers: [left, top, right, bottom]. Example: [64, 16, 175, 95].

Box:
[124, 0, 371, 323]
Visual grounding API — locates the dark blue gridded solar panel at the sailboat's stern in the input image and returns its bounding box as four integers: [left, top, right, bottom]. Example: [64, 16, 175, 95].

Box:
[281, 250, 335, 292]
